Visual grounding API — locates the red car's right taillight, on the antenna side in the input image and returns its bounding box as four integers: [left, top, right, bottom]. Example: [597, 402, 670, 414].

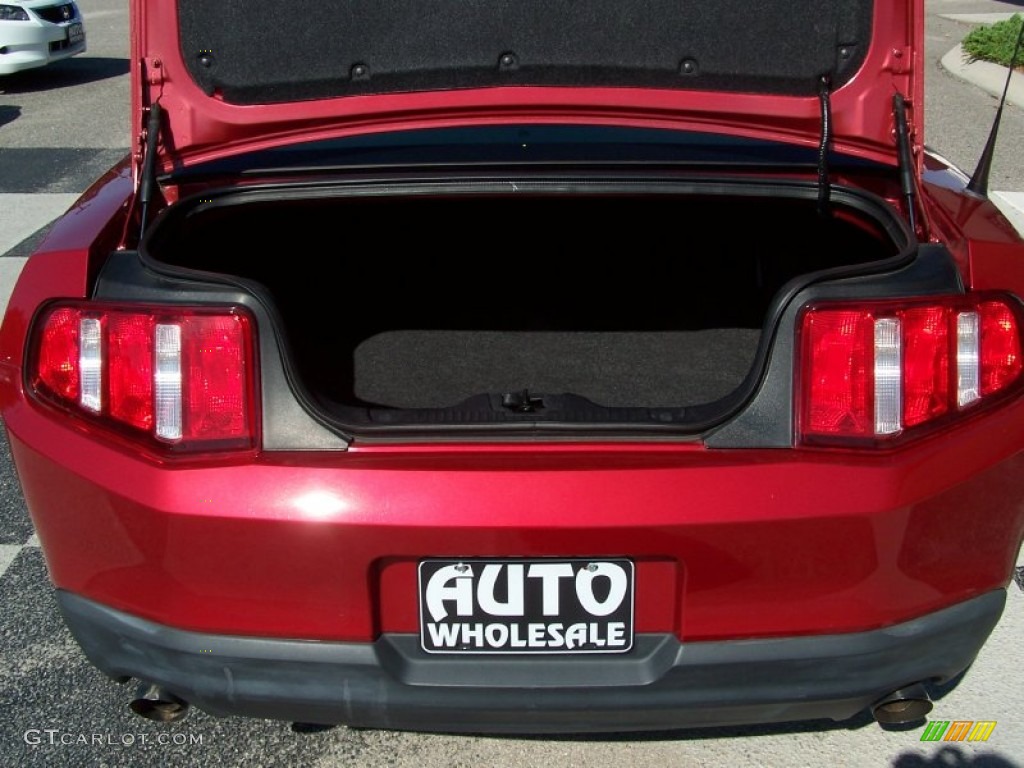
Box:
[797, 294, 1022, 444]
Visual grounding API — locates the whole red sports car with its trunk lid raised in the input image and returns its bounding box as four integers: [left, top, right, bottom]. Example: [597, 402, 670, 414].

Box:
[0, 0, 1024, 732]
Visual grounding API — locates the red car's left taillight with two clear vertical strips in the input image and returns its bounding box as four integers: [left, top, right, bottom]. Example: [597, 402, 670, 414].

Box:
[29, 303, 256, 451]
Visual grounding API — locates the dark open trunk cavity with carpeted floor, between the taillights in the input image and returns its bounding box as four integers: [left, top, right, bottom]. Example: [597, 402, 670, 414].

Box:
[144, 184, 902, 434]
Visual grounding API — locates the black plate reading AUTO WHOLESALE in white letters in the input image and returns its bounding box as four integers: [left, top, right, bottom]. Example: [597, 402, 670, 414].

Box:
[419, 558, 634, 653]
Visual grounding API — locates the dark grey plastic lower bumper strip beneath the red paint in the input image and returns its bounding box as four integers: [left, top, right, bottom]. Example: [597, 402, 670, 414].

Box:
[58, 590, 1006, 733]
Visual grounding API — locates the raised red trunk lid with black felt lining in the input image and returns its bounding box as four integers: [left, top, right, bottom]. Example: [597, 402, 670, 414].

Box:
[132, 0, 923, 176]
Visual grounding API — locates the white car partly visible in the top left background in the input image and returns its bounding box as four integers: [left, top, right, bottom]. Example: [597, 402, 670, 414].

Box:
[0, 0, 85, 75]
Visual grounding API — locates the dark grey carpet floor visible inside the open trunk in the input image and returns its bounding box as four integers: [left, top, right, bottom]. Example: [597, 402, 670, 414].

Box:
[353, 329, 761, 409]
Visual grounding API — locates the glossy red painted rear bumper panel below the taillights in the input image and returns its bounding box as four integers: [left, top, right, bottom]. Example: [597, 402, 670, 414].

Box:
[7, 382, 1024, 640]
